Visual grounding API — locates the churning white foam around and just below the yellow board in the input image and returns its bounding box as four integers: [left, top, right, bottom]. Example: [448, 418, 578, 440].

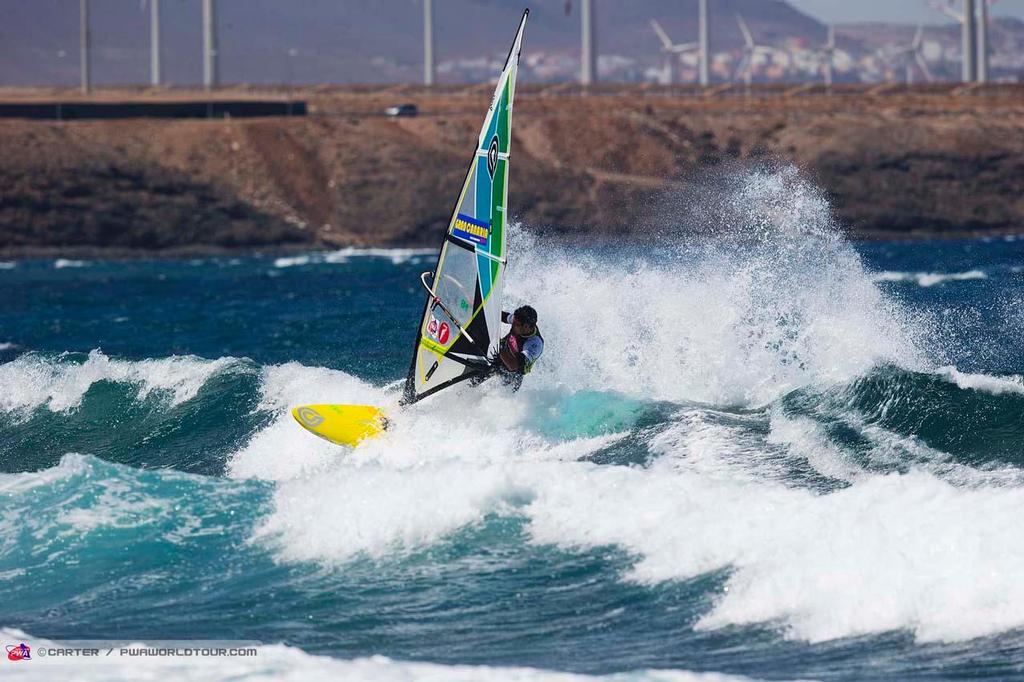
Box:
[234, 364, 621, 564]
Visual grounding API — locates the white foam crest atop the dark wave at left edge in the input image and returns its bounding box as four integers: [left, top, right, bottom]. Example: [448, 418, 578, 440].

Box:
[0, 350, 238, 412]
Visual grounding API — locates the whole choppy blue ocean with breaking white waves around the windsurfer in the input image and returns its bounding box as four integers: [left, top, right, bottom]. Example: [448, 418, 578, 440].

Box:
[0, 173, 1024, 680]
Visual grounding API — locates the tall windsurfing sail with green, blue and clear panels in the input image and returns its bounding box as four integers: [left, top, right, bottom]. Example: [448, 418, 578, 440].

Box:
[402, 9, 529, 403]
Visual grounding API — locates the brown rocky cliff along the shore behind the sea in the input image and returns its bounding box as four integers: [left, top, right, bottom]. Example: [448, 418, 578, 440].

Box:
[0, 87, 1024, 253]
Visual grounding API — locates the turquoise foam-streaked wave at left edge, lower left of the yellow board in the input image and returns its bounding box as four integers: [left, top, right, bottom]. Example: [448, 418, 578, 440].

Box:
[0, 454, 266, 569]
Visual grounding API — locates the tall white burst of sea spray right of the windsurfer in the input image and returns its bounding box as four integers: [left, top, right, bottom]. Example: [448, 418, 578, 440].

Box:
[506, 169, 927, 406]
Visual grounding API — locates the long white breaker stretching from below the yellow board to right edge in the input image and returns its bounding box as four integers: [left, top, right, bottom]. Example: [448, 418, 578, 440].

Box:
[241, 405, 1024, 642]
